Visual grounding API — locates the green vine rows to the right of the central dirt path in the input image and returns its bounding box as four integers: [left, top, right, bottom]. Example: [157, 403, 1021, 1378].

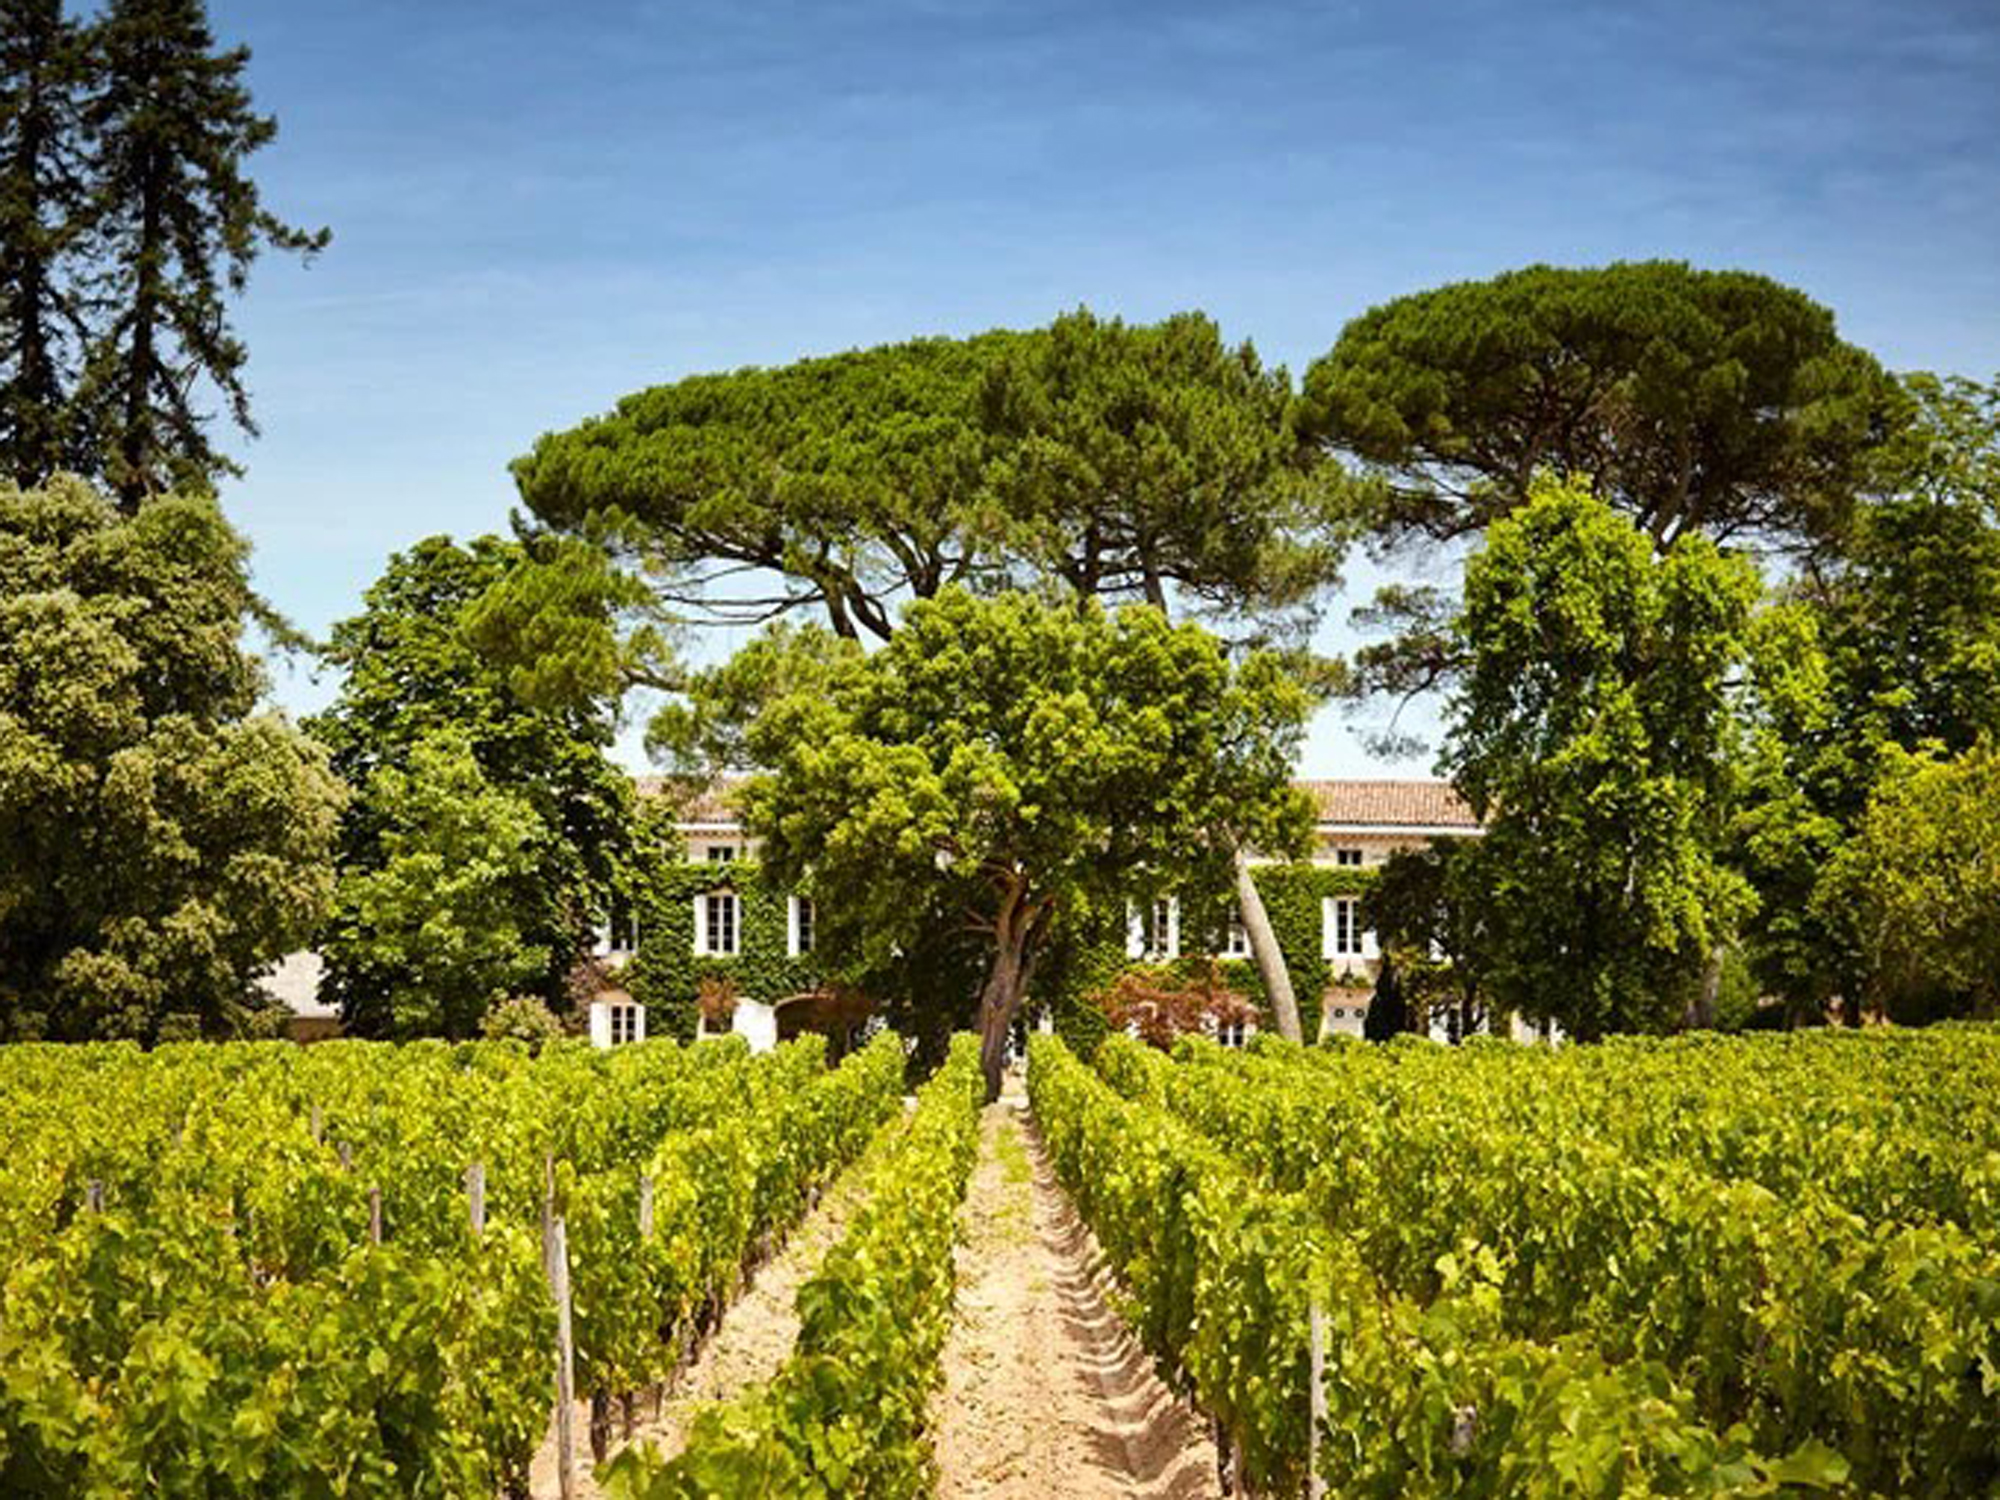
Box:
[1056, 1028, 2000, 1496]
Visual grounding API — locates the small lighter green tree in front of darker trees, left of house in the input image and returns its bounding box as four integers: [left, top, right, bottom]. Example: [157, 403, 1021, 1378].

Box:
[322, 730, 550, 1038]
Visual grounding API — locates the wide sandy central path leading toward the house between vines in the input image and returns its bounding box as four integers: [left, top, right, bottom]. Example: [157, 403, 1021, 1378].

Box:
[932, 1096, 1220, 1500]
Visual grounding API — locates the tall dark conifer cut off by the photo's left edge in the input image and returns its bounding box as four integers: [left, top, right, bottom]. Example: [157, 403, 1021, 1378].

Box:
[0, 0, 88, 486]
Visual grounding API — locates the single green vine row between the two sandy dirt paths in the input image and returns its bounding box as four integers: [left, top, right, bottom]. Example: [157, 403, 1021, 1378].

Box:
[604, 1036, 982, 1500]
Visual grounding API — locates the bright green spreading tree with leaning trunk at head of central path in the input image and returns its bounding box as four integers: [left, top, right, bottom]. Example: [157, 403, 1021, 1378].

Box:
[744, 590, 1310, 1096]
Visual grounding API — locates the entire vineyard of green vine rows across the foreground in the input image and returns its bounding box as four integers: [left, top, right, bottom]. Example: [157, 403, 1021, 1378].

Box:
[0, 1028, 2000, 1500]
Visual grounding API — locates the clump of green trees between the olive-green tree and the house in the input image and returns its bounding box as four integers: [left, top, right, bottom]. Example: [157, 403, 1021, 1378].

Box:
[308, 536, 640, 1036]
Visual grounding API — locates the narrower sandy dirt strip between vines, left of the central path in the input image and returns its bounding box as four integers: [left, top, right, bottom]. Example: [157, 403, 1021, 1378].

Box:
[528, 1120, 900, 1500]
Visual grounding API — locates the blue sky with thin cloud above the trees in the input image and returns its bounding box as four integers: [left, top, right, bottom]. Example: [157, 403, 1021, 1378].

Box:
[212, 0, 2000, 774]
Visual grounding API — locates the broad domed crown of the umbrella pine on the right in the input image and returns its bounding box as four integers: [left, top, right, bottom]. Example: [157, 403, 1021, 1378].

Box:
[1306, 260, 1904, 550]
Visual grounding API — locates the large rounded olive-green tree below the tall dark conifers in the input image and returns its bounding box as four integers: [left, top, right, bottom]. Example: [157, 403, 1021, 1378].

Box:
[0, 478, 344, 1040]
